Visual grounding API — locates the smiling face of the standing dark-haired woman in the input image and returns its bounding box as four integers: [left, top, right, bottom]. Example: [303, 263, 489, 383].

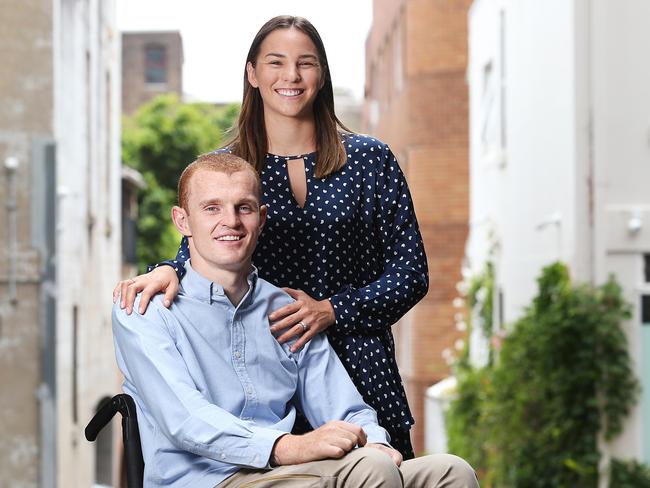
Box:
[246, 28, 323, 122]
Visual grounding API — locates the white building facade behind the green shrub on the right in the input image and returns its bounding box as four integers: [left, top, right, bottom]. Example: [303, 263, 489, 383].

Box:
[467, 0, 650, 480]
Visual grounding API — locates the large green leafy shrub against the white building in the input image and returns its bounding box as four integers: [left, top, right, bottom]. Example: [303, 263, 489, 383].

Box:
[448, 263, 638, 488]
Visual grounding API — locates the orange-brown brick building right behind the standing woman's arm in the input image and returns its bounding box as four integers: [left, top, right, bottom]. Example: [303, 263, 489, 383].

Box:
[363, 0, 471, 452]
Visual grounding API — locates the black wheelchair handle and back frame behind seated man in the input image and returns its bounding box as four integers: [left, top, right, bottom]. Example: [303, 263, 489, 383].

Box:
[85, 393, 144, 488]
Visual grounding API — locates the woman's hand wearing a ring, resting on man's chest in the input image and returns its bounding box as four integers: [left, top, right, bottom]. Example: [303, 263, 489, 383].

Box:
[269, 288, 336, 352]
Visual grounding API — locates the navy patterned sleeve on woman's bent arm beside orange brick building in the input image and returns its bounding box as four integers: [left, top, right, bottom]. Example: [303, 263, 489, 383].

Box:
[330, 146, 429, 332]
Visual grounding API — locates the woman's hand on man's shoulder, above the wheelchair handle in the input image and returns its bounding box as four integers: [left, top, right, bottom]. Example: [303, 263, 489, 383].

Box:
[113, 266, 178, 315]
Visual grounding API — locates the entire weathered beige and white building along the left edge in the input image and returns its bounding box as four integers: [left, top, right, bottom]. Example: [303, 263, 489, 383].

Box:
[0, 0, 121, 487]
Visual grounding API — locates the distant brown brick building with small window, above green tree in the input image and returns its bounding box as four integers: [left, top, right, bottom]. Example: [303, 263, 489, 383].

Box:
[122, 31, 183, 115]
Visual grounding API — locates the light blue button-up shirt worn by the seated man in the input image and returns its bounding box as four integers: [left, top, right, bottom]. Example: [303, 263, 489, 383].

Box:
[113, 262, 389, 487]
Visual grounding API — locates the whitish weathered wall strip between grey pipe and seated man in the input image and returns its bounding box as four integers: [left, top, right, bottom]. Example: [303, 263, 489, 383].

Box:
[54, 0, 121, 486]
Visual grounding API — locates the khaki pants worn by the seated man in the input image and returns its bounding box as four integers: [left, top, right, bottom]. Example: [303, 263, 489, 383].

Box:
[217, 447, 479, 488]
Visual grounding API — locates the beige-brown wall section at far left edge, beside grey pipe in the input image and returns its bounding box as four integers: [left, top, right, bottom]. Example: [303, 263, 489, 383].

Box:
[0, 0, 53, 487]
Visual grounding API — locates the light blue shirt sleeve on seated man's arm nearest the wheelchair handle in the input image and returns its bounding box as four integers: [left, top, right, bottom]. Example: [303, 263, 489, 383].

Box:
[113, 305, 286, 469]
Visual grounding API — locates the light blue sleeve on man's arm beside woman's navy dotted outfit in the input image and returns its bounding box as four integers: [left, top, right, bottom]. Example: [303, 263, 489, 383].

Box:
[296, 334, 390, 444]
